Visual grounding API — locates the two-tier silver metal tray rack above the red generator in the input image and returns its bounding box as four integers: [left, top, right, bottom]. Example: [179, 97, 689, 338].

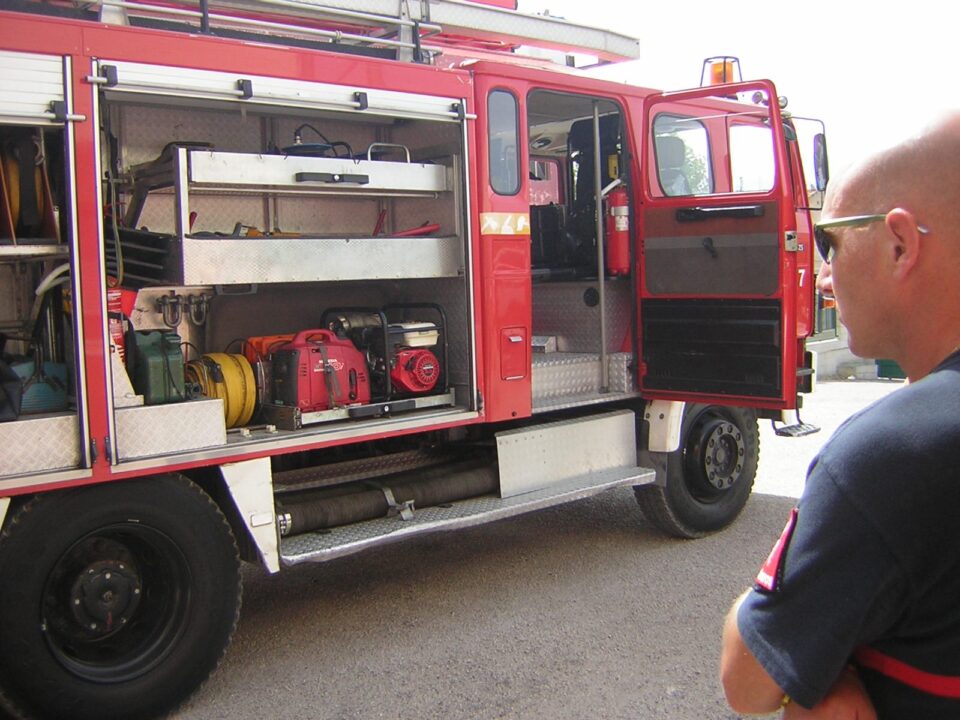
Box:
[121, 146, 464, 285]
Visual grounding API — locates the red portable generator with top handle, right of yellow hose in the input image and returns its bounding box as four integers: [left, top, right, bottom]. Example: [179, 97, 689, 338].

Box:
[271, 330, 370, 412]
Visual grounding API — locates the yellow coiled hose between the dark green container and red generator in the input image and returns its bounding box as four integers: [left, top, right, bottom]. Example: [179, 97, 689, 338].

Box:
[183, 353, 257, 428]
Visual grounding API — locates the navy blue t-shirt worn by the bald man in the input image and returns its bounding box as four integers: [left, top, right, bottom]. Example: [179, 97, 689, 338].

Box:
[737, 354, 960, 720]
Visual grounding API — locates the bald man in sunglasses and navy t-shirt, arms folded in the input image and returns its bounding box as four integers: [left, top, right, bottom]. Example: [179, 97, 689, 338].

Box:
[721, 113, 960, 720]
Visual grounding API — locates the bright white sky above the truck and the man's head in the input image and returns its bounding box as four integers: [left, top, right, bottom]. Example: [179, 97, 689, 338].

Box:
[519, 0, 960, 175]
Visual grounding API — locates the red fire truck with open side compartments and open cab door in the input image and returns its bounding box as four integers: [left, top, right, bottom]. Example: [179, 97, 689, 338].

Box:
[0, 0, 824, 718]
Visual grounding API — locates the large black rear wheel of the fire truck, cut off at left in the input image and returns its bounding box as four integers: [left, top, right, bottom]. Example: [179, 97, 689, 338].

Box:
[0, 476, 241, 720]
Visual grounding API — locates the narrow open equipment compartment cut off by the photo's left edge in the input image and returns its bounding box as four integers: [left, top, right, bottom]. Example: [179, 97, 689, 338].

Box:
[0, 52, 85, 477]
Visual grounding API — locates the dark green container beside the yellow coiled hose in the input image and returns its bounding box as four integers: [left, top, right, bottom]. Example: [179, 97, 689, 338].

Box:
[128, 330, 186, 405]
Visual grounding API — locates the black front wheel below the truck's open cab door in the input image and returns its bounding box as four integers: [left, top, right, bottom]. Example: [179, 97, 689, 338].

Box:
[634, 405, 760, 538]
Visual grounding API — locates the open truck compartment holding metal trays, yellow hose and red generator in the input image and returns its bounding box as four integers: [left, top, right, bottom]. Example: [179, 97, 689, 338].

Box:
[101, 59, 475, 459]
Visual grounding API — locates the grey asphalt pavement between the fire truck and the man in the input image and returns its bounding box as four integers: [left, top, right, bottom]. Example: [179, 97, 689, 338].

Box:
[175, 381, 901, 720]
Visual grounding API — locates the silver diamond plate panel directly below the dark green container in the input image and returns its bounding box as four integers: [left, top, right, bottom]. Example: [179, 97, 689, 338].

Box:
[116, 398, 227, 460]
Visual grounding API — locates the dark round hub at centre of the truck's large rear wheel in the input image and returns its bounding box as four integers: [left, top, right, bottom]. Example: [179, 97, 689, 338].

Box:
[70, 560, 142, 635]
